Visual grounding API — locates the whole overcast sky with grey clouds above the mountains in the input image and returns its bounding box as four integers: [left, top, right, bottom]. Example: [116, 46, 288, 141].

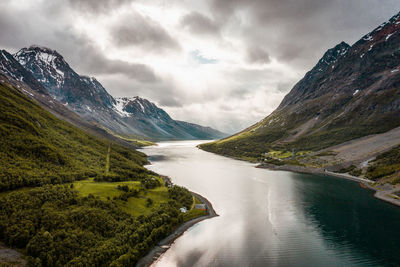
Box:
[0, 0, 400, 133]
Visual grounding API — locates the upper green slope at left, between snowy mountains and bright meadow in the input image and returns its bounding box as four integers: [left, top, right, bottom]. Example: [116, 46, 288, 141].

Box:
[0, 83, 147, 191]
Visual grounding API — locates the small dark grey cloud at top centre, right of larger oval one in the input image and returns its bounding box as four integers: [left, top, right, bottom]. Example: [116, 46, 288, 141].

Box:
[181, 12, 220, 35]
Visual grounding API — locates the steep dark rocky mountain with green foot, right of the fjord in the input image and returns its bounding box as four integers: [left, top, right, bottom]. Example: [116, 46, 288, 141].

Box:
[201, 10, 400, 182]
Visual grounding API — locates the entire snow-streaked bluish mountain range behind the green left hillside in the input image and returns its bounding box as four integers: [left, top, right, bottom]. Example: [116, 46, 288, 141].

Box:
[14, 46, 225, 140]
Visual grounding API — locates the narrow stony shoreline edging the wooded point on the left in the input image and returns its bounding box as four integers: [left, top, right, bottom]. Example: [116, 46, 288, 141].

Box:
[136, 192, 218, 267]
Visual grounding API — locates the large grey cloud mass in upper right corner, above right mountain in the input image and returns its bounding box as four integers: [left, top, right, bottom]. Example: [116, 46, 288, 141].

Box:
[210, 0, 400, 68]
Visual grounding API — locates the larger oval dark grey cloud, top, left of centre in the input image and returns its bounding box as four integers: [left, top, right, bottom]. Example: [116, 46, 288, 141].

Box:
[110, 12, 180, 51]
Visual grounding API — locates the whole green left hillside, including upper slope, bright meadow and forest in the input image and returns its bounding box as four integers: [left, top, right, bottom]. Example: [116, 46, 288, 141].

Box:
[0, 84, 203, 266]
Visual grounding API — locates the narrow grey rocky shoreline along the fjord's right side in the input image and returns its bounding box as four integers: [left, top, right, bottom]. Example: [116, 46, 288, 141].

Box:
[256, 163, 400, 207]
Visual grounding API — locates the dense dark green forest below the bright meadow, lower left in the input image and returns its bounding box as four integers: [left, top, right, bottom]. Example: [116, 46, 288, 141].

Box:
[0, 185, 192, 266]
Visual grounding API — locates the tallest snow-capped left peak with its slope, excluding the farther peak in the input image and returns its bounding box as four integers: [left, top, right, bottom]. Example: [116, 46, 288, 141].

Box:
[14, 46, 132, 137]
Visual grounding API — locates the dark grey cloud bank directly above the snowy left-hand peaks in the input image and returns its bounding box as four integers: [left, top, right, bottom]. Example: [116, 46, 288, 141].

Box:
[0, 2, 158, 83]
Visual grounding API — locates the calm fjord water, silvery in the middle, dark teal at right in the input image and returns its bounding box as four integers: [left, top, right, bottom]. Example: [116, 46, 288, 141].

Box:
[142, 141, 400, 266]
